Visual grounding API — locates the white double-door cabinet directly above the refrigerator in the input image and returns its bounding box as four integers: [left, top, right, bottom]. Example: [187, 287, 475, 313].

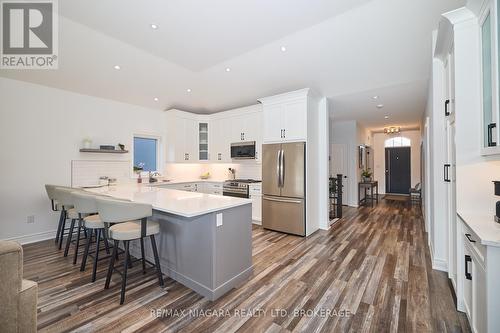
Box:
[260, 89, 310, 143]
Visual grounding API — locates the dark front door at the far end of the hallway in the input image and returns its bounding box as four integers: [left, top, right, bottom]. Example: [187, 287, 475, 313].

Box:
[385, 147, 411, 194]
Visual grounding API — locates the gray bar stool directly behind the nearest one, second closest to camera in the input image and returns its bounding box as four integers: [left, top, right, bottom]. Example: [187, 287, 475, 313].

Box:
[72, 192, 113, 282]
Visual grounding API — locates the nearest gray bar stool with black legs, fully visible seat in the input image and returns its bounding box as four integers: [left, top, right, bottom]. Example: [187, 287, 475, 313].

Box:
[95, 197, 164, 304]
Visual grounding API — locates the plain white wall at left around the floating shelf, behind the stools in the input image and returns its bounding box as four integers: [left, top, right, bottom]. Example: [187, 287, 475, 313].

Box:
[0, 78, 166, 240]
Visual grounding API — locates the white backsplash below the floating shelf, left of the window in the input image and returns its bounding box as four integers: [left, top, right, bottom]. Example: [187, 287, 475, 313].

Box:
[71, 160, 132, 187]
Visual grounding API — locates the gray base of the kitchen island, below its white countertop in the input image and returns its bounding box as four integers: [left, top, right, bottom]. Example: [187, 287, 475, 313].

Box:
[131, 204, 253, 300]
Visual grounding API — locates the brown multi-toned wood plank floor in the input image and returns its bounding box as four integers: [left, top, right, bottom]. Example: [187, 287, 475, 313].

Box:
[24, 200, 470, 332]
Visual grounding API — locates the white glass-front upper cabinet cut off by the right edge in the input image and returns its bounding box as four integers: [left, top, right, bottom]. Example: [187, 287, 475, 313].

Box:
[479, 0, 500, 155]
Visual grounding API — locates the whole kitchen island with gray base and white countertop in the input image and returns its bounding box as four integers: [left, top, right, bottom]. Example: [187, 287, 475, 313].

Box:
[87, 184, 252, 300]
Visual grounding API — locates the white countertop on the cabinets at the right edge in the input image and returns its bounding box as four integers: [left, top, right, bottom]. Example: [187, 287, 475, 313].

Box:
[457, 211, 500, 247]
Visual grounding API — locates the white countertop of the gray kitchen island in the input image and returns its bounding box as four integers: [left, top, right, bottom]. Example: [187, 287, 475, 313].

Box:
[86, 183, 252, 217]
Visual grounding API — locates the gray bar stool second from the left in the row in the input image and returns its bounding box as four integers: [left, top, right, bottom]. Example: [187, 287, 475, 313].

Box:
[56, 187, 87, 265]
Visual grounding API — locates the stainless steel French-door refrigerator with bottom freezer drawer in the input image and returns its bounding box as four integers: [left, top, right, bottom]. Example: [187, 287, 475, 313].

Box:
[262, 142, 306, 236]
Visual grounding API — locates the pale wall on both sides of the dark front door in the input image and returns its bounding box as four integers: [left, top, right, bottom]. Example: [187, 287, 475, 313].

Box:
[372, 130, 422, 193]
